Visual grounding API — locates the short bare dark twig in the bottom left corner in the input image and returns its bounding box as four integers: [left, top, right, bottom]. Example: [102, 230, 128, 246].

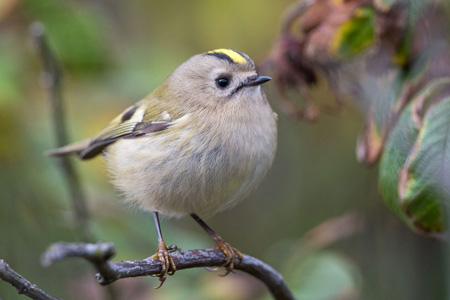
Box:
[0, 259, 58, 300]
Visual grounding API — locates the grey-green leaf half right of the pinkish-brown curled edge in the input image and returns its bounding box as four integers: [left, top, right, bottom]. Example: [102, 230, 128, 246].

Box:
[399, 97, 450, 232]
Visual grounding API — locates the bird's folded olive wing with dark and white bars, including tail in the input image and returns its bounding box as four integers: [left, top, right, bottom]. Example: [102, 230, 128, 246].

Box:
[46, 99, 181, 159]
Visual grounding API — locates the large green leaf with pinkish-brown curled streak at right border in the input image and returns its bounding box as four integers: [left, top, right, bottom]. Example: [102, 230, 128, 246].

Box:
[379, 78, 450, 232]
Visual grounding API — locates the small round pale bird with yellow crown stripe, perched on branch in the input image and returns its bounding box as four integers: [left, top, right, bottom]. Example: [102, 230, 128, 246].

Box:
[46, 49, 277, 287]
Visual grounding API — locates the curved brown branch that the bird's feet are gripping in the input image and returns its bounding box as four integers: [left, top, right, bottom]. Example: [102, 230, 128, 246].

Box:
[42, 243, 295, 300]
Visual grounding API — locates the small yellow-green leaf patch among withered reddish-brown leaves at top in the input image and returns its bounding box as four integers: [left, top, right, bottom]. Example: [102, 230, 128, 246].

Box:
[330, 7, 376, 58]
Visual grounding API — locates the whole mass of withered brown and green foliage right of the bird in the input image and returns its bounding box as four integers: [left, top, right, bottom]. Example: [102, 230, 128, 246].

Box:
[261, 0, 450, 236]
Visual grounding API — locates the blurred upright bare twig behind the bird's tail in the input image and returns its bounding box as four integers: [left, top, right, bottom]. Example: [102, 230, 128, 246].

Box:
[30, 22, 93, 242]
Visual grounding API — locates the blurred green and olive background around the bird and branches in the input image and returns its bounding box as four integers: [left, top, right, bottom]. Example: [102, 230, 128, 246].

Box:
[0, 0, 448, 300]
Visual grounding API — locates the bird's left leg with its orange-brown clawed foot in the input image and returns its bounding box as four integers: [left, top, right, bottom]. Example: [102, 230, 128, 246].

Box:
[151, 211, 177, 289]
